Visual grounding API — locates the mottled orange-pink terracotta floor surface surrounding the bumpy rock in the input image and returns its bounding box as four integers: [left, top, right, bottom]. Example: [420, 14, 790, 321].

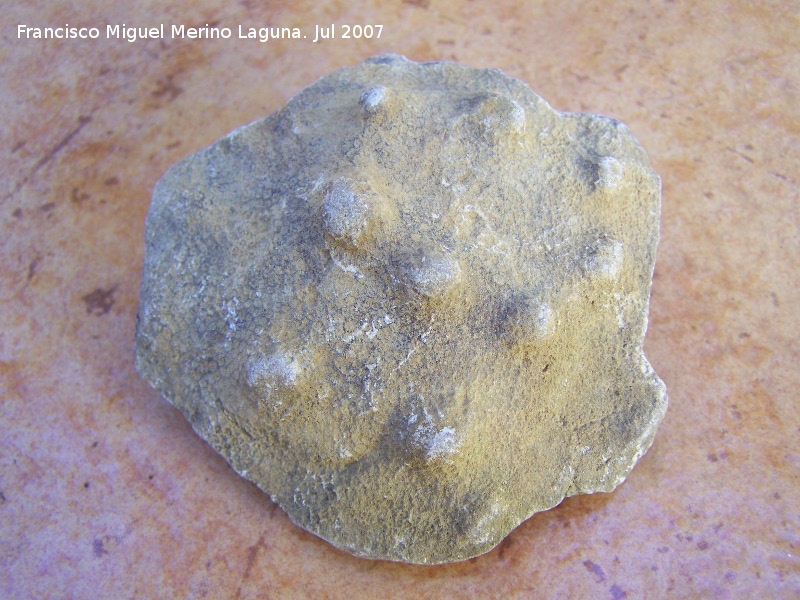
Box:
[0, 0, 800, 600]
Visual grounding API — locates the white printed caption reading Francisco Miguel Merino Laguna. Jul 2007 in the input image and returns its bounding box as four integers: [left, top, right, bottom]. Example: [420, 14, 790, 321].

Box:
[17, 23, 383, 43]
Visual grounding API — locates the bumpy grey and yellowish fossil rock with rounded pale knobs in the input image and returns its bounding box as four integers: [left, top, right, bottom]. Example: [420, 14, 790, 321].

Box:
[136, 55, 667, 564]
